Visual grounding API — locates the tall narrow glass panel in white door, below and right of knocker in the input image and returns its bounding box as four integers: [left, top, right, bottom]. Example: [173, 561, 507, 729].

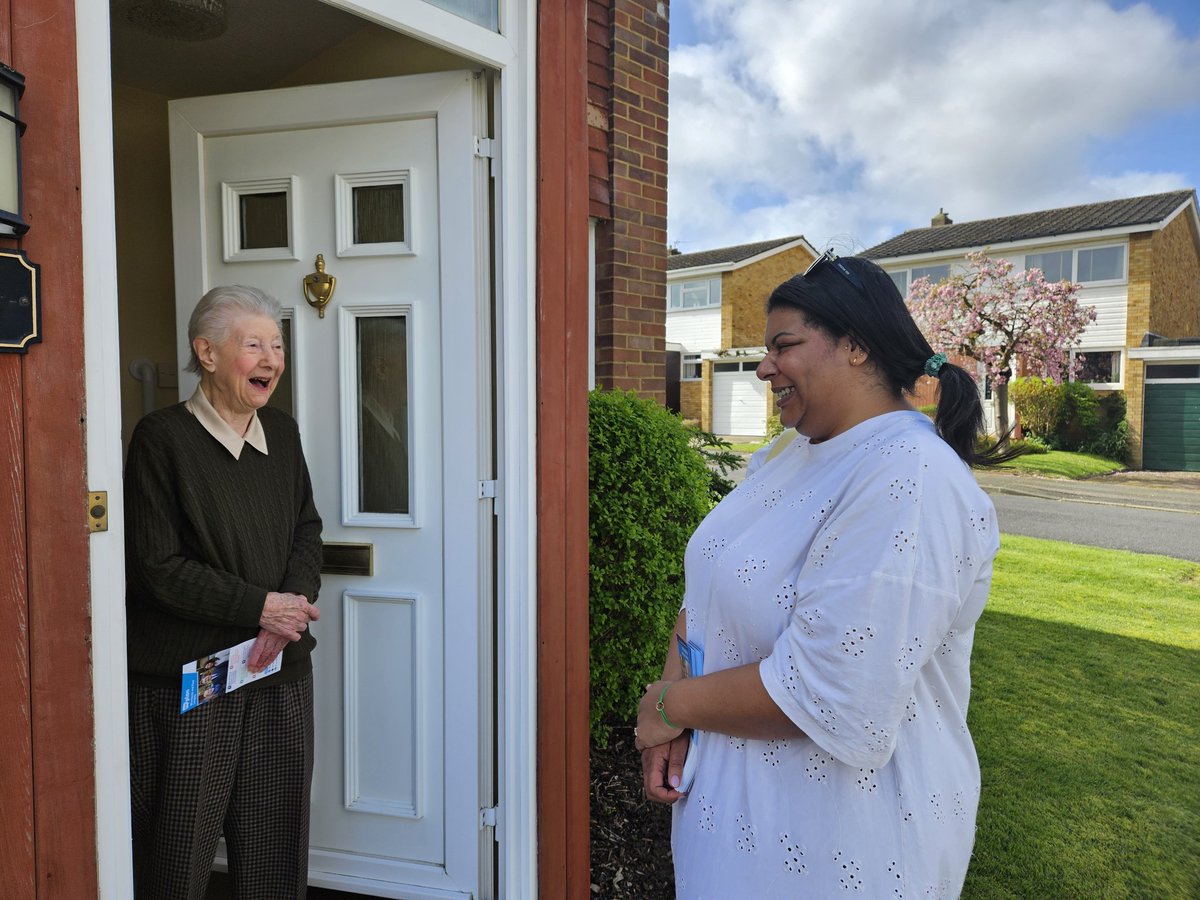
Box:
[356, 316, 409, 515]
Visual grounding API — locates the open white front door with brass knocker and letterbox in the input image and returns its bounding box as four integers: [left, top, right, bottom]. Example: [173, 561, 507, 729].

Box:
[170, 72, 494, 898]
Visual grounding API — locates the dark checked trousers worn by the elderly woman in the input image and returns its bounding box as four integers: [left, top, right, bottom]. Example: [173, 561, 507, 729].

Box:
[130, 673, 313, 900]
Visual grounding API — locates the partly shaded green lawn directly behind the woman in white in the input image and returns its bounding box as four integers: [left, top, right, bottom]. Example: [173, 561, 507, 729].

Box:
[962, 534, 1200, 900]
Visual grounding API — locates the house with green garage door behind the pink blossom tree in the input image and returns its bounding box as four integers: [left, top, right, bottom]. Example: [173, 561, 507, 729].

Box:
[864, 190, 1200, 472]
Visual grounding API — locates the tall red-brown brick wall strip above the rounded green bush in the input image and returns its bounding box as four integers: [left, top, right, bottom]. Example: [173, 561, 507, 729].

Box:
[588, 0, 668, 403]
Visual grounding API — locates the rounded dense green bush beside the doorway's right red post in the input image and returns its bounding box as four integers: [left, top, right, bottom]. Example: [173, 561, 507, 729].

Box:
[588, 390, 713, 745]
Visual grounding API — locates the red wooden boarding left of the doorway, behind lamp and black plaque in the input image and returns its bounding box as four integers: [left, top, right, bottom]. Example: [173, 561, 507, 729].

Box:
[0, 0, 97, 899]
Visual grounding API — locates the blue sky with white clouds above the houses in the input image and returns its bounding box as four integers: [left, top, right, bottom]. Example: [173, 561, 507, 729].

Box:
[667, 0, 1200, 253]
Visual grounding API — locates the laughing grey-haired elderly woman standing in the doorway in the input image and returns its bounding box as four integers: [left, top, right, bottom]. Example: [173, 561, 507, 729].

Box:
[125, 286, 322, 900]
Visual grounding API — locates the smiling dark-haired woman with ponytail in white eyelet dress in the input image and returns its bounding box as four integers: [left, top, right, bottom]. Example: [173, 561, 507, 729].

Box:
[636, 253, 1007, 899]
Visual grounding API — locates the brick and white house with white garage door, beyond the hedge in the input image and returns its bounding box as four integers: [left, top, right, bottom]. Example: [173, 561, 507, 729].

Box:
[666, 235, 817, 437]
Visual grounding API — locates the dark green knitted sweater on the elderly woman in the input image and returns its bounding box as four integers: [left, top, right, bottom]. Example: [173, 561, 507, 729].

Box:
[125, 403, 322, 690]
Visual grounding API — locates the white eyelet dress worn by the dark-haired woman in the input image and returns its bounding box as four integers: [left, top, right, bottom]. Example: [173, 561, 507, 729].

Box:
[672, 412, 1000, 900]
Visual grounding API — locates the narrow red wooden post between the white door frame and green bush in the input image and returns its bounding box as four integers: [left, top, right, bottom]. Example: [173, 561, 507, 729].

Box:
[536, 0, 590, 900]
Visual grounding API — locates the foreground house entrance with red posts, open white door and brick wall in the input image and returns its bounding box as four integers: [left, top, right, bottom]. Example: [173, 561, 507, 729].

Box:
[0, 0, 668, 900]
